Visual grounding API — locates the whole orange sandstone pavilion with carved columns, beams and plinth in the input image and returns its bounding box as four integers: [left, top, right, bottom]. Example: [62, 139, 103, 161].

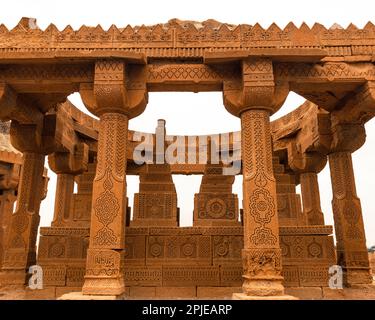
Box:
[0, 18, 375, 299]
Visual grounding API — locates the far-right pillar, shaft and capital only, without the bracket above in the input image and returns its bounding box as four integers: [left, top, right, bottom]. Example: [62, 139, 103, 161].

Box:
[328, 125, 372, 286]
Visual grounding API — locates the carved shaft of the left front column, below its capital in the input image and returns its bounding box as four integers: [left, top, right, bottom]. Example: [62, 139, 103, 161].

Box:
[83, 113, 128, 295]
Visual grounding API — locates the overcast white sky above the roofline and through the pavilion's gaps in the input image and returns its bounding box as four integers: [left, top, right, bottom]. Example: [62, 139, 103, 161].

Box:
[0, 0, 375, 246]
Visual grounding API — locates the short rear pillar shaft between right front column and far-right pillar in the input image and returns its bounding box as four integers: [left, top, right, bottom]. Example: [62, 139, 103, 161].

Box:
[300, 172, 324, 225]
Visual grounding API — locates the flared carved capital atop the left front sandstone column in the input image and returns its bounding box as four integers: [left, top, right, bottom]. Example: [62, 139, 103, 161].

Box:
[79, 59, 148, 118]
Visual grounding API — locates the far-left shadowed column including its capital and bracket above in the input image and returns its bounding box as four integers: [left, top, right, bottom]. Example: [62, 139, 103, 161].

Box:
[0, 83, 52, 286]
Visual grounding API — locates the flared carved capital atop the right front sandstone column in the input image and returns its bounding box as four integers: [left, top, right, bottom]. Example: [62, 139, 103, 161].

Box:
[223, 58, 289, 117]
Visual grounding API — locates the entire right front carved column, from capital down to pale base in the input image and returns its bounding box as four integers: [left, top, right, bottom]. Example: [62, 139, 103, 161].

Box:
[224, 58, 288, 299]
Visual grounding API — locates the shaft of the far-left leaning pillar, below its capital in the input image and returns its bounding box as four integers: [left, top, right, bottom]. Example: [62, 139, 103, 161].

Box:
[2, 152, 45, 285]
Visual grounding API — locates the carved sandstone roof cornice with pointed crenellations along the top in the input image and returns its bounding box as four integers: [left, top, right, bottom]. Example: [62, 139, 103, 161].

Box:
[0, 18, 375, 63]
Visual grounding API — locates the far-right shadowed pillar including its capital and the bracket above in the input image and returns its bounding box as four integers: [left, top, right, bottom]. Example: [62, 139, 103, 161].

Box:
[328, 81, 375, 286]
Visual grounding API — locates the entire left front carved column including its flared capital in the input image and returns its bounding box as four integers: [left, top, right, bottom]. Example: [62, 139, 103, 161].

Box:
[80, 60, 147, 296]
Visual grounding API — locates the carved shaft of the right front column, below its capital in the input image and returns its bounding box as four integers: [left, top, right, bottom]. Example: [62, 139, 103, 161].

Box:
[241, 110, 283, 296]
